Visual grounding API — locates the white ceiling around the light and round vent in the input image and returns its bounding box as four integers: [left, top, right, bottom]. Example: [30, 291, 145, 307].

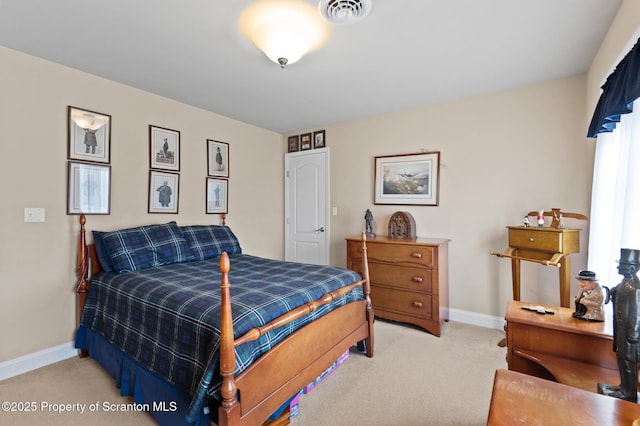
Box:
[0, 0, 622, 134]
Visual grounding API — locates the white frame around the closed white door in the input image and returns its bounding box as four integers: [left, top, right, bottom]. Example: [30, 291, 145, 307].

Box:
[284, 147, 331, 265]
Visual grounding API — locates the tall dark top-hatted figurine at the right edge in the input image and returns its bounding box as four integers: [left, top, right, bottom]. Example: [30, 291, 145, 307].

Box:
[598, 248, 640, 402]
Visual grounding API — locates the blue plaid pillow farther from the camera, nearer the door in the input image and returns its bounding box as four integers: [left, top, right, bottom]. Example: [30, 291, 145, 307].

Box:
[181, 225, 242, 260]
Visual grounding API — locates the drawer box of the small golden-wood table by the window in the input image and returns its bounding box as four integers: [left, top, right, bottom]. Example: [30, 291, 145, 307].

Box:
[509, 228, 580, 254]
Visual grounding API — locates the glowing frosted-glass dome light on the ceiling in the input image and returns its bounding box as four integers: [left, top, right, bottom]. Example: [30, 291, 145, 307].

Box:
[239, 0, 331, 68]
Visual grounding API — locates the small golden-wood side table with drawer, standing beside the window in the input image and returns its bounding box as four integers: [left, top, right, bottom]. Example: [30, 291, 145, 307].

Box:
[491, 226, 580, 308]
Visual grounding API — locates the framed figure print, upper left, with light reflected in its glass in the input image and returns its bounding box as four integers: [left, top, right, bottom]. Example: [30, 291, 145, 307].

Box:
[67, 106, 111, 163]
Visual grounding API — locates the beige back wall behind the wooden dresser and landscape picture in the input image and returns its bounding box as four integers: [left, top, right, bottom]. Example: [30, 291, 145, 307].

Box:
[314, 76, 593, 317]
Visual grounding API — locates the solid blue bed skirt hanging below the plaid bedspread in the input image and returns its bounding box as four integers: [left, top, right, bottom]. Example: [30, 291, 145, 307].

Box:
[75, 326, 210, 426]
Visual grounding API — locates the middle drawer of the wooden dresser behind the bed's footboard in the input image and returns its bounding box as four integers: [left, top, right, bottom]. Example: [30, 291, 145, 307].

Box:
[368, 263, 431, 293]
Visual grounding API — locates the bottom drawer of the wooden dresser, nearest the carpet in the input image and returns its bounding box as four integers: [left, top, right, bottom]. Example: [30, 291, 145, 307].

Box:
[371, 285, 432, 318]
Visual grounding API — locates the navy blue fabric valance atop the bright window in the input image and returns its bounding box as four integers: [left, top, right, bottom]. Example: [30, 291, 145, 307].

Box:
[587, 40, 640, 138]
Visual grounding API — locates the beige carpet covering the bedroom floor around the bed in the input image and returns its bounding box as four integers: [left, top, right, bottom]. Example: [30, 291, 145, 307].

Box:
[0, 320, 506, 426]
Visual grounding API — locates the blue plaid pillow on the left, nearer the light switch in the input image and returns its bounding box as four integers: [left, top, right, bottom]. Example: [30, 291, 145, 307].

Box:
[102, 222, 195, 273]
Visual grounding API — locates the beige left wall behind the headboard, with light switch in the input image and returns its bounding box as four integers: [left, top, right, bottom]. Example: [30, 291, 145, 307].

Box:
[0, 47, 284, 362]
